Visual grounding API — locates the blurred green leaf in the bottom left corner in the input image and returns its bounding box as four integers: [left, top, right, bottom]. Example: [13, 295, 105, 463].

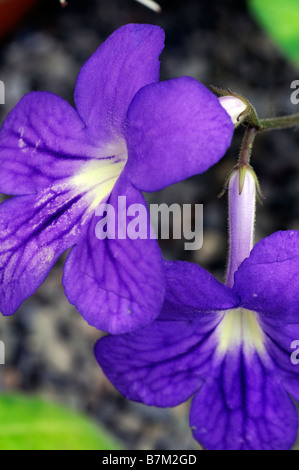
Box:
[0, 395, 121, 450]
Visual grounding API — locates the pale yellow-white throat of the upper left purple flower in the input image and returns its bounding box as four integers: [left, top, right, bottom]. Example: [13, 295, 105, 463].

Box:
[70, 142, 128, 211]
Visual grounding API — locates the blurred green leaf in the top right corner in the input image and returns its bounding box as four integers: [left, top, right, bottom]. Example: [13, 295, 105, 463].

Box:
[248, 0, 299, 66]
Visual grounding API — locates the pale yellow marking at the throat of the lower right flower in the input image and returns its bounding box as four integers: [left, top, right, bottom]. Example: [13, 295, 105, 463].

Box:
[218, 308, 265, 353]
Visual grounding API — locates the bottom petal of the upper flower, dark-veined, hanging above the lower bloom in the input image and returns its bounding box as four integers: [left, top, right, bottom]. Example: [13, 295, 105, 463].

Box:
[63, 178, 165, 334]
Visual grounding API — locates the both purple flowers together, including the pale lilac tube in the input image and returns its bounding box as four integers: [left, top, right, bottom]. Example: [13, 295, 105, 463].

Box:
[0, 25, 299, 449]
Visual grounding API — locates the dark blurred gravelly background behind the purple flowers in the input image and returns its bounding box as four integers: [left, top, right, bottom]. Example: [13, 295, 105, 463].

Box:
[0, 0, 299, 450]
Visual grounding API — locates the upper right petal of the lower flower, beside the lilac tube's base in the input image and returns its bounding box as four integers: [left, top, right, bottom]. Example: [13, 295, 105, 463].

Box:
[234, 230, 299, 324]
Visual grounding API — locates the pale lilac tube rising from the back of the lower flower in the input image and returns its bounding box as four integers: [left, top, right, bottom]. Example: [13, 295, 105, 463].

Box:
[226, 167, 256, 287]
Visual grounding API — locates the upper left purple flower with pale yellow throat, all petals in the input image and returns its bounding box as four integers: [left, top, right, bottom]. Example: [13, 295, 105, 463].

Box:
[0, 24, 233, 333]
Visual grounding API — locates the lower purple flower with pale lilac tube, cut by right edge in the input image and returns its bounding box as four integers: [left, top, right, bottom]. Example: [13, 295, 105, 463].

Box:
[95, 168, 299, 450]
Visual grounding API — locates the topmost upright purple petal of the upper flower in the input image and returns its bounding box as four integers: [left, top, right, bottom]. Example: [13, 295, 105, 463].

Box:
[75, 24, 164, 140]
